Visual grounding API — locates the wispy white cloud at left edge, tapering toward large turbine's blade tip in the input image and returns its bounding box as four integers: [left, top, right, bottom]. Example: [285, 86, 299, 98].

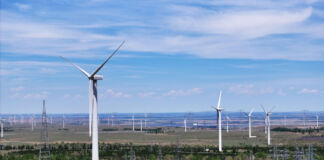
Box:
[0, 11, 122, 57]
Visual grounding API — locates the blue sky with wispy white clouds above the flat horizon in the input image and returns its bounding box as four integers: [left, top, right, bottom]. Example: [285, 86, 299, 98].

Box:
[0, 0, 324, 113]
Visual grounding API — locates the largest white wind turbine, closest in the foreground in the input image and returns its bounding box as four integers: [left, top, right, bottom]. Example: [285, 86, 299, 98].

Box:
[61, 41, 125, 160]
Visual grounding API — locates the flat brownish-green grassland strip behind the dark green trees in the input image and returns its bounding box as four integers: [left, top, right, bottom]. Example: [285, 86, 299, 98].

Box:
[1, 126, 324, 147]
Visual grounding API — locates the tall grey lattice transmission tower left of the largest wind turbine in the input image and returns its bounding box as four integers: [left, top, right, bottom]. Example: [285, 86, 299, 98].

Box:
[39, 100, 51, 160]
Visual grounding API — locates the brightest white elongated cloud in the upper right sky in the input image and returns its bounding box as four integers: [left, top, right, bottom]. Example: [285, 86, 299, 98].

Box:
[168, 7, 313, 38]
